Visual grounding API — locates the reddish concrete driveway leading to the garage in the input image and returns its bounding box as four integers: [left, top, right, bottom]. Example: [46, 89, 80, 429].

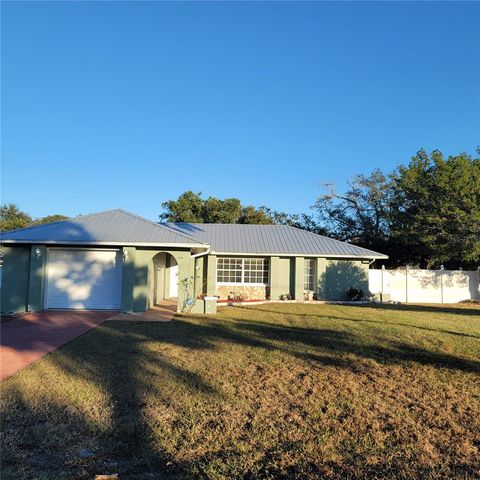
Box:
[0, 310, 117, 381]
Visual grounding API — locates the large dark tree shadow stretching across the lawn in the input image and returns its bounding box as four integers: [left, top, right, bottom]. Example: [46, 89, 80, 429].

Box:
[3, 307, 480, 480]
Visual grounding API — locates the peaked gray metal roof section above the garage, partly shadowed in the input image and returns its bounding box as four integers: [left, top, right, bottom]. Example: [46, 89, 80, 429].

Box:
[0, 209, 202, 247]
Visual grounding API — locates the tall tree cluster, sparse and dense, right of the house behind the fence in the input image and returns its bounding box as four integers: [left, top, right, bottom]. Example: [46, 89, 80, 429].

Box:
[315, 150, 480, 268]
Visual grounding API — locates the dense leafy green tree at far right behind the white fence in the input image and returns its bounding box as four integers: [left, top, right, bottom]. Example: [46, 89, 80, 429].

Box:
[392, 150, 480, 268]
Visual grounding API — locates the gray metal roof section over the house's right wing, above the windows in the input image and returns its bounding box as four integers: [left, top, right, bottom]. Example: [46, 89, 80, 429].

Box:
[164, 223, 388, 258]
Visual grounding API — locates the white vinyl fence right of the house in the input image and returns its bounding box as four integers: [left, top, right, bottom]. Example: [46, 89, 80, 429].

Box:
[368, 268, 480, 303]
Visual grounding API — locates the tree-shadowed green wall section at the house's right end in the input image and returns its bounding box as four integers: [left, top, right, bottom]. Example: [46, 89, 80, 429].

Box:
[321, 260, 369, 300]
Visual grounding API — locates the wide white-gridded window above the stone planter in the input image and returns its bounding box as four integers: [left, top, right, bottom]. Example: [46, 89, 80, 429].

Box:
[217, 258, 269, 285]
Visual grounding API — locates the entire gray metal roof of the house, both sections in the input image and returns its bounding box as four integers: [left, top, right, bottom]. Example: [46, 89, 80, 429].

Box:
[0, 209, 387, 258]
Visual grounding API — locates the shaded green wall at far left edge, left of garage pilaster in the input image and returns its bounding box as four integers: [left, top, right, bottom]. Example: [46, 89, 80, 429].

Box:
[0, 245, 30, 313]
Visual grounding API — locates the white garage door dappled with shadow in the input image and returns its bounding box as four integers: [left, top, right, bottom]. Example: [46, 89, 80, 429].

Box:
[46, 248, 122, 310]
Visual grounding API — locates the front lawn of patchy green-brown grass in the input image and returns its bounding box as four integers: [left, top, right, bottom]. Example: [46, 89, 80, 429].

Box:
[1, 304, 480, 480]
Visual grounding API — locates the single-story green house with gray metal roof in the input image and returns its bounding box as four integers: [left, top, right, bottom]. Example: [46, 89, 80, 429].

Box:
[0, 210, 387, 313]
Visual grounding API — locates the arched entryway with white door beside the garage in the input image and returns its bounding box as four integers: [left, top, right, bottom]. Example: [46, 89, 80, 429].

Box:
[153, 252, 178, 305]
